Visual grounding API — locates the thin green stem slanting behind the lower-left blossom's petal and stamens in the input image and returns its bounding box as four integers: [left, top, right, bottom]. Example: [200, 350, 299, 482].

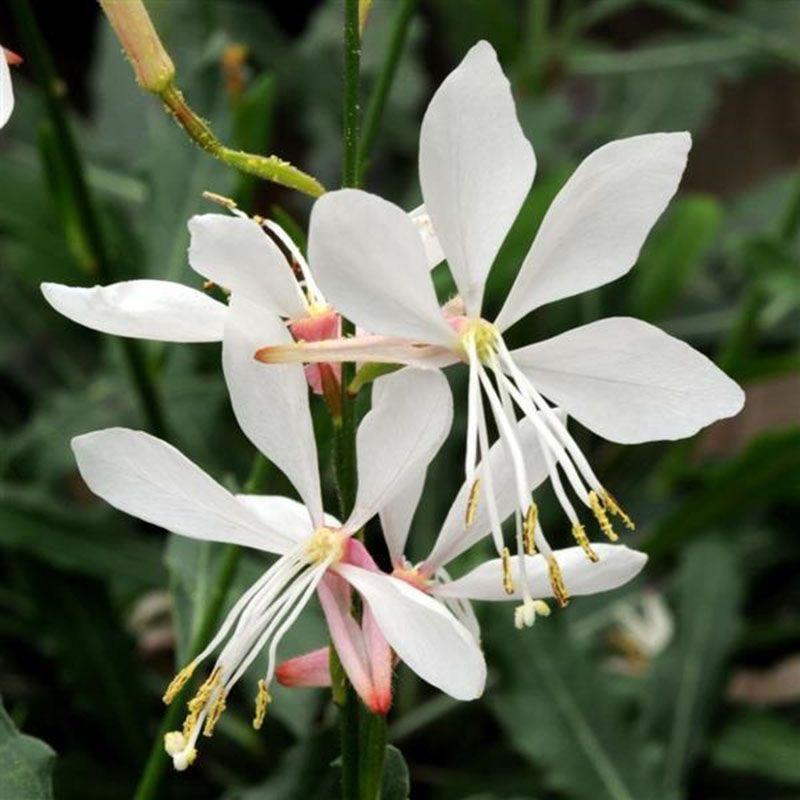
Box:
[134, 453, 269, 800]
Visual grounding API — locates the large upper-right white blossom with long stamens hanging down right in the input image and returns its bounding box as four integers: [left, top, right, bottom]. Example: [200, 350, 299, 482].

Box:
[257, 37, 743, 600]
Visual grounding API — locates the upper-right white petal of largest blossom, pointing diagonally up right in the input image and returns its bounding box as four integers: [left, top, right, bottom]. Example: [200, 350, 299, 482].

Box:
[496, 133, 692, 330]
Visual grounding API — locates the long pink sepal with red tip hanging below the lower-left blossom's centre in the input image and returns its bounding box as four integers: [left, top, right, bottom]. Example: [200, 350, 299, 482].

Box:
[317, 567, 392, 714]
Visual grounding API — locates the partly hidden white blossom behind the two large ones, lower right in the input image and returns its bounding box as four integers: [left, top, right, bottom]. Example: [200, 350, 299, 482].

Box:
[278, 400, 647, 700]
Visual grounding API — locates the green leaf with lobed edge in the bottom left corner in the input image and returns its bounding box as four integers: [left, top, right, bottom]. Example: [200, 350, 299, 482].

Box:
[0, 704, 56, 800]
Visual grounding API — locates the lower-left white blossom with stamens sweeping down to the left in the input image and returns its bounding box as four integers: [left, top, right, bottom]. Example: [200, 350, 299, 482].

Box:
[73, 324, 486, 770]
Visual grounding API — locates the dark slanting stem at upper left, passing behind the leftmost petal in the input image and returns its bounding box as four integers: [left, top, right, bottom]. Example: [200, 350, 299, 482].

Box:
[11, 0, 166, 437]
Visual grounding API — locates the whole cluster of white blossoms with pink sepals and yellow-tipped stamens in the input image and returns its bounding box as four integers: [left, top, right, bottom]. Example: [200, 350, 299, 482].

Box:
[42, 42, 743, 769]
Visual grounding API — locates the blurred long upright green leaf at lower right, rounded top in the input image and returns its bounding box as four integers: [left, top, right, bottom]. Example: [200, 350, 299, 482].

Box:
[644, 540, 743, 792]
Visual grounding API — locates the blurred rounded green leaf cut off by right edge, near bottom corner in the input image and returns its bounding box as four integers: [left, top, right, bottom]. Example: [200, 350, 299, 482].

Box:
[711, 711, 800, 786]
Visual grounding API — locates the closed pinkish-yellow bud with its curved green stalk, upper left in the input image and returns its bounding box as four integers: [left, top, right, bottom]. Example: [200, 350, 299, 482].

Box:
[100, 0, 325, 197]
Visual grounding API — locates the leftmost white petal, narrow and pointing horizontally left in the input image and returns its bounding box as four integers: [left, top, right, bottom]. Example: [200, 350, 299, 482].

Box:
[41, 280, 227, 342]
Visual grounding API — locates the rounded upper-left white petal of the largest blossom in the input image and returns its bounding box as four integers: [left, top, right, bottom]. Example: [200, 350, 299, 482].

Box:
[308, 189, 456, 346]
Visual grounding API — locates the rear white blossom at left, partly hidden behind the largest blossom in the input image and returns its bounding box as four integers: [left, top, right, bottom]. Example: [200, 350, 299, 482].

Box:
[41, 203, 441, 394]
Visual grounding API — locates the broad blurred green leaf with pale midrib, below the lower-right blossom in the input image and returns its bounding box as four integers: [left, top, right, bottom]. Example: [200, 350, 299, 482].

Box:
[484, 609, 659, 800]
